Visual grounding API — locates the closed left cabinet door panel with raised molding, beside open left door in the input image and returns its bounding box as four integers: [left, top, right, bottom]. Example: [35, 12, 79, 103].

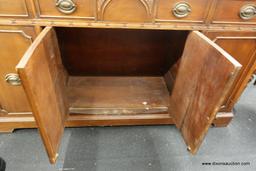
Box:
[0, 26, 36, 114]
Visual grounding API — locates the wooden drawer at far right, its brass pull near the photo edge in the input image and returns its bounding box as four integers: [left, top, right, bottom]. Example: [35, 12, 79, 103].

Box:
[213, 0, 256, 24]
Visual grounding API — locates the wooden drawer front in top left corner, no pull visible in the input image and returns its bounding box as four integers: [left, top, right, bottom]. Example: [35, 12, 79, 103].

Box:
[0, 0, 29, 17]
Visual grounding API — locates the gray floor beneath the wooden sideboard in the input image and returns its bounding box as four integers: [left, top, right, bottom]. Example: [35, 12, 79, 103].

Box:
[0, 79, 256, 171]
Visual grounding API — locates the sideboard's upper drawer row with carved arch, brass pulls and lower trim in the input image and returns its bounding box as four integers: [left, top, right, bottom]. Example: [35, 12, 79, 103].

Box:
[0, 0, 256, 31]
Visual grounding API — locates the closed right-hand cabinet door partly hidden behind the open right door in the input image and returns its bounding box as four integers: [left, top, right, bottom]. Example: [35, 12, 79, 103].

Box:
[205, 31, 256, 112]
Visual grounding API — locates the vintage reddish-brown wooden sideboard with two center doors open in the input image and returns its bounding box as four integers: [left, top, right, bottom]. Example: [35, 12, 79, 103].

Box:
[0, 0, 256, 163]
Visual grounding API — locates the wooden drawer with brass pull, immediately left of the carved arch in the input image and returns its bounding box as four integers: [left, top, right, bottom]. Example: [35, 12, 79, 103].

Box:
[35, 0, 96, 19]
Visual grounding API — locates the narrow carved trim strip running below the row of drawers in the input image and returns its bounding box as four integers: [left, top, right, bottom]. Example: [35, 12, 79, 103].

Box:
[0, 19, 256, 32]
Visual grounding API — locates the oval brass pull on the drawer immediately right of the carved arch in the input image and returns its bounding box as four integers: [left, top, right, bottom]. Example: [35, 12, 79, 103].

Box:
[172, 2, 192, 18]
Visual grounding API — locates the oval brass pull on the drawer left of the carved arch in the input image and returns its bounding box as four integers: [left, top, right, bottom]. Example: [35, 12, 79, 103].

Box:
[56, 0, 76, 14]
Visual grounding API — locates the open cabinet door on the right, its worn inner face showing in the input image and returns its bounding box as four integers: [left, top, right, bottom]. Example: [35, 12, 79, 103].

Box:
[170, 31, 241, 154]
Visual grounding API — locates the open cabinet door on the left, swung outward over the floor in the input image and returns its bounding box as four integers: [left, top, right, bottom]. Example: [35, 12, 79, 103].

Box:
[16, 27, 68, 163]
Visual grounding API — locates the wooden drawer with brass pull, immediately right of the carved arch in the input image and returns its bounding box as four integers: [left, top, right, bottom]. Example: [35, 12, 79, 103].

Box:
[155, 0, 211, 23]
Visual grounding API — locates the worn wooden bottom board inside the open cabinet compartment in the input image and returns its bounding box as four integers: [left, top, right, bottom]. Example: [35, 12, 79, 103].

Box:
[68, 77, 169, 114]
